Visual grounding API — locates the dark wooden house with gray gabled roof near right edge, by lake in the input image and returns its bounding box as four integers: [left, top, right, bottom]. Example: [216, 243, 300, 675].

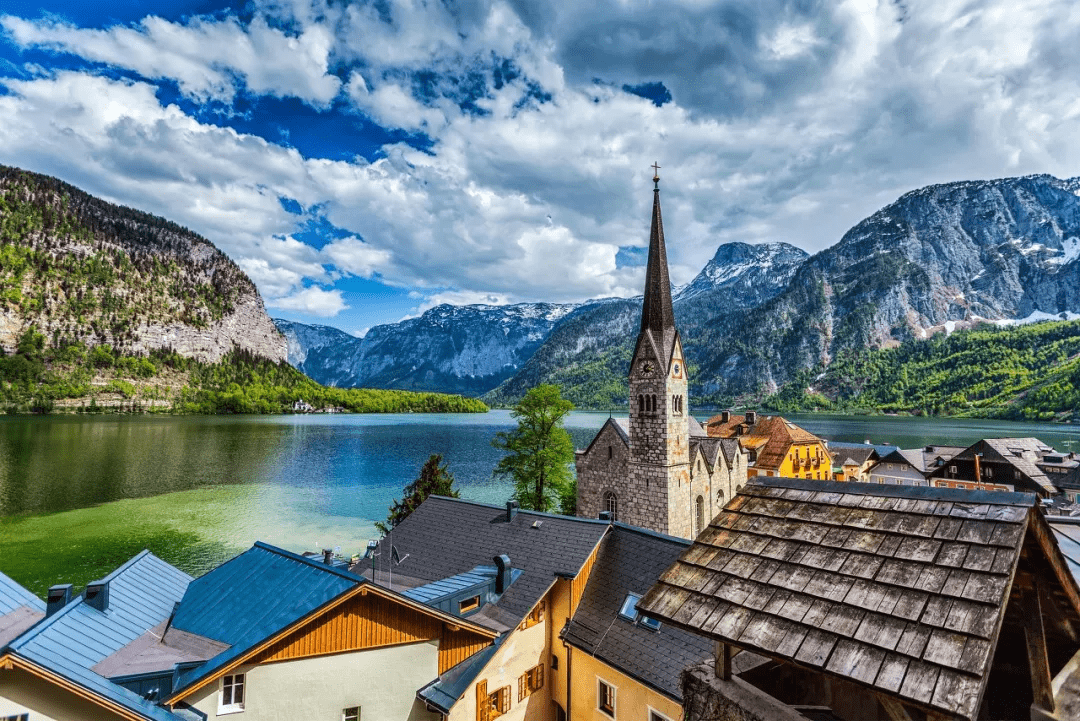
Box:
[930, 438, 1061, 499]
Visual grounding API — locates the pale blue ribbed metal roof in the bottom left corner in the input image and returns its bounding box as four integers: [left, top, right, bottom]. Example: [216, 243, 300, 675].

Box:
[8, 550, 191, 721]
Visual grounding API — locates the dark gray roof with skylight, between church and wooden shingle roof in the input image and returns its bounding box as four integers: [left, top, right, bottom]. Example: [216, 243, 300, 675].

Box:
[562, 523, 713, 702]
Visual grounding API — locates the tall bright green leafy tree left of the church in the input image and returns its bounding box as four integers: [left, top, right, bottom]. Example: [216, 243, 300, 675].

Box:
[491, 384, 573, 511]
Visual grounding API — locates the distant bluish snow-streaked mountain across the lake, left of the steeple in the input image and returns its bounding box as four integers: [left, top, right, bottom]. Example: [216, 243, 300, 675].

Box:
[275, 303, 578, 395]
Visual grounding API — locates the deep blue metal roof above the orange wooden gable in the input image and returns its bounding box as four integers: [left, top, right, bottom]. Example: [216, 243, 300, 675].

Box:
[173, 542, 364, 691]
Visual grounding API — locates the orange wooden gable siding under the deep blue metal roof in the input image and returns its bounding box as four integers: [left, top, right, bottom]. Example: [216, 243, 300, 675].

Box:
[248, 594, 489, 672]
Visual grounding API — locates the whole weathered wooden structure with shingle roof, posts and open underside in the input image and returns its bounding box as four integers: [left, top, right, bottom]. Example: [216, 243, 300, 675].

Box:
[637, 477, 1080, 721]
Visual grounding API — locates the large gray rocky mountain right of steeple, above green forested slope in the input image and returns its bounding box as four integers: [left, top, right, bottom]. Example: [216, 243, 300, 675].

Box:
[687, 175, 1080, 397]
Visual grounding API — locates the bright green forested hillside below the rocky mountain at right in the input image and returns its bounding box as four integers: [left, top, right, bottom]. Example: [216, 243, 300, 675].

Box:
[765, 321, 1080, 420]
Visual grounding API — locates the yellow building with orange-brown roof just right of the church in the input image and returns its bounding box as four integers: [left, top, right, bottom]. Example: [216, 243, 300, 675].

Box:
[705, 411, 833, 480]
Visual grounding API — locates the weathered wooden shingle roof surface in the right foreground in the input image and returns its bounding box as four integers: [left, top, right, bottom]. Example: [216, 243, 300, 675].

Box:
[638, 477, 1077, 719]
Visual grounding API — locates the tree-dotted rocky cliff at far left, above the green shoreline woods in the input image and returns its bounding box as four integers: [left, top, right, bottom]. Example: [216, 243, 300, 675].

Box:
[0, 166, 286, 363]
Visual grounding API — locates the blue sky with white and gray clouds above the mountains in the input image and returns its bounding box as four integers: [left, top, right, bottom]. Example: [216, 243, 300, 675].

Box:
[0, 0, 1080, 335]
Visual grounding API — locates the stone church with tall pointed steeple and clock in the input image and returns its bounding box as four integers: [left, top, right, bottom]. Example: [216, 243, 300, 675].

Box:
[575, 175, 746, 539]
